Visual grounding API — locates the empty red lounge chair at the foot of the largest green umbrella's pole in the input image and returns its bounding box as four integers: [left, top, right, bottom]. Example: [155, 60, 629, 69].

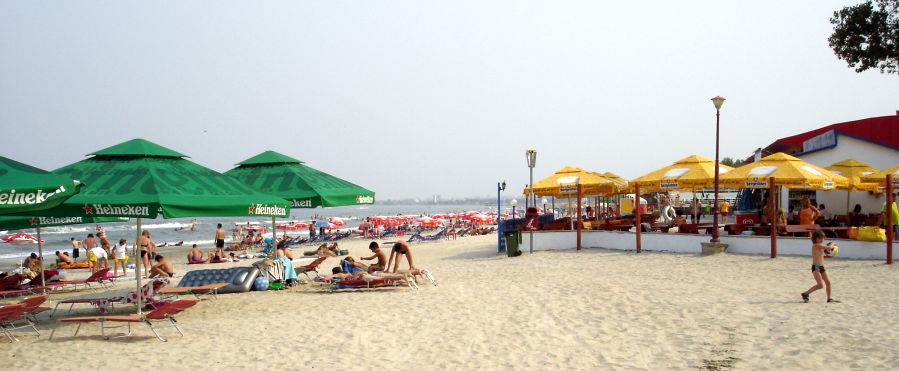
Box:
[50, 299, 199, 342]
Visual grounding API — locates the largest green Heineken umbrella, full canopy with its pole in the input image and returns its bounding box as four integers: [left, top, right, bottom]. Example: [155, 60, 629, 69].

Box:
[29, 139, 290, 315]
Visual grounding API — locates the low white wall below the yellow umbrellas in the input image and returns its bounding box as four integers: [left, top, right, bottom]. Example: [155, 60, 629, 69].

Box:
[519, 230, 886, 260]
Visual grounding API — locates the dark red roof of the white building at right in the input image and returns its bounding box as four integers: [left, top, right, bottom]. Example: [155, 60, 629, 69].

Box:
[747, 111, 899, 162]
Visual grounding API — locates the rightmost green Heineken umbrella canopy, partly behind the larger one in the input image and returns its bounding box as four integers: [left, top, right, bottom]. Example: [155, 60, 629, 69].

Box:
[225, 151, 375, 208]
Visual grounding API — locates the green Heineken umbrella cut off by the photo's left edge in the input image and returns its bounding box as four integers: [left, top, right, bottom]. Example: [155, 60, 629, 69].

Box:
[0, 156, 82, 215]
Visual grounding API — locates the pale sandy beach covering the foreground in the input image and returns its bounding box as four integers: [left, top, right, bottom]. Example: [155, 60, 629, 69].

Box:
[0, 234, 899, 370]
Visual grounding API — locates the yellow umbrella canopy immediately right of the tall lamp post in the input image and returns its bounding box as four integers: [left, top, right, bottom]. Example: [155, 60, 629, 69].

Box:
[720, 152, 849, 190]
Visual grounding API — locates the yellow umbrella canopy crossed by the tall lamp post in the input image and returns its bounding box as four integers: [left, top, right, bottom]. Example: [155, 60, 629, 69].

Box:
[630, 155, 733, 192]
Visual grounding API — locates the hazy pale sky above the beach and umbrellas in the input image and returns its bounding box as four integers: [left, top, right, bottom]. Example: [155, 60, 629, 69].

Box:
[0, 0, 899, 199]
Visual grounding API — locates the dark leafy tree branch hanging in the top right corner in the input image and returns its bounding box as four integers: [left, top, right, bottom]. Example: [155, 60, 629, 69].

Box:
[827, 0, 899, 73]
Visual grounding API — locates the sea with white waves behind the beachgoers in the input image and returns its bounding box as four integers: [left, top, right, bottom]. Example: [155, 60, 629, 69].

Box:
[0, 203, 492, 265]
